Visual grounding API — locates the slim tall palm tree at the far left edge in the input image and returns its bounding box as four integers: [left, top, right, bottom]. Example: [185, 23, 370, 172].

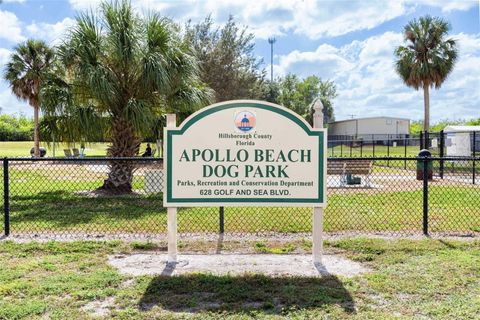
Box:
[4, 40, 54, 157]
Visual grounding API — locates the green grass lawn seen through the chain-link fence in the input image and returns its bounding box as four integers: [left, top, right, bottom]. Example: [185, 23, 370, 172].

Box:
[0, 166, 480, 235]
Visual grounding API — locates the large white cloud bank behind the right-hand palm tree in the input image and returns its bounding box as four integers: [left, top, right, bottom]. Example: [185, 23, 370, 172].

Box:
[275, 32, 480, 121]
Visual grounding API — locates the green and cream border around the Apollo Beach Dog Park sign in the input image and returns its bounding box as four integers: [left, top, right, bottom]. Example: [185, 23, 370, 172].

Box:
[163, 100, 327, 208]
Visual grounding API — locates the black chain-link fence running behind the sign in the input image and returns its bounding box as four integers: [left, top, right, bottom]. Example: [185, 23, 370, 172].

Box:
[0, 156, 480, 238]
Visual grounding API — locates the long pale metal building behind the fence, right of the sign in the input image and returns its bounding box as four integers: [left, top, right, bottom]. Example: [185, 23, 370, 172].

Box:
[328, 117, 410, 140]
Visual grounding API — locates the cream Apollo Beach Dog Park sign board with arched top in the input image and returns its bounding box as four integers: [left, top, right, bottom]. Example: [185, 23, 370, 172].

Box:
[164, 100, 326, 207]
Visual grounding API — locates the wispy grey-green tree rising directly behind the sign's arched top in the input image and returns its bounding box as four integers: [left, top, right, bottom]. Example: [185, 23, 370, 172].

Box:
[186, 16, 264, 102]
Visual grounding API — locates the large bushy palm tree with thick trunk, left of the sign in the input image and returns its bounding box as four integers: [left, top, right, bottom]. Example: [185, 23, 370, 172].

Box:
[42, 1, 211, 193]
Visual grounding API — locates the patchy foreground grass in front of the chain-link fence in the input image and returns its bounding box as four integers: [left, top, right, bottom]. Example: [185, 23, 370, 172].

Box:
[0, 239, 480, 320]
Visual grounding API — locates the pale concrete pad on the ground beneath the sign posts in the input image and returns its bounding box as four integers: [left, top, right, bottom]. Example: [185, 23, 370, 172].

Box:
[109, 253, 369, 277]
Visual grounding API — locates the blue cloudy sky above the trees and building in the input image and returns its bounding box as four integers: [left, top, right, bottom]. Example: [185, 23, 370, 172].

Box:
[0, 0, 480, 121]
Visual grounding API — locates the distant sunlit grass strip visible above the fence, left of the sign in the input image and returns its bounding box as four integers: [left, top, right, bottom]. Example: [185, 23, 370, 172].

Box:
[0, 141, 158, 158]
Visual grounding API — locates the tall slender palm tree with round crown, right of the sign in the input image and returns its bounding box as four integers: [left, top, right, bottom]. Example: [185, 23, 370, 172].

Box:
[395, 15, 457, 131]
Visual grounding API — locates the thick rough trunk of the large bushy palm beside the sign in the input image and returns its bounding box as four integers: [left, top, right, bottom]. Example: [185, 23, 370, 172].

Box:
[100, 119, 140, 194]
